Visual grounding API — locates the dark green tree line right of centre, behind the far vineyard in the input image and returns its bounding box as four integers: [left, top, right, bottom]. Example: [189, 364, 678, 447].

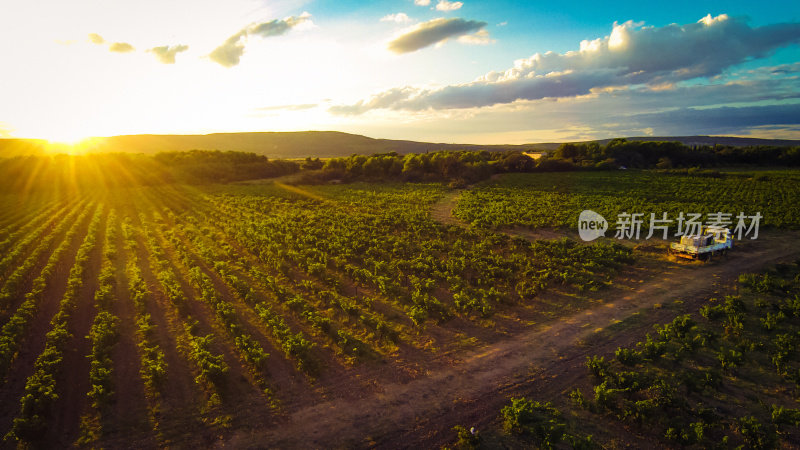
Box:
[299, 138, 800, 185]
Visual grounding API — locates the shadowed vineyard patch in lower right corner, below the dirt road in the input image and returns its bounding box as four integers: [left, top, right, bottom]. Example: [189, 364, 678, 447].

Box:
[482, 263, 800, 448]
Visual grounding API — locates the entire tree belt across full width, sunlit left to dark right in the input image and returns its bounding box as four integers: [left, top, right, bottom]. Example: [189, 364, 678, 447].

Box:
[0, 138, 800, 192]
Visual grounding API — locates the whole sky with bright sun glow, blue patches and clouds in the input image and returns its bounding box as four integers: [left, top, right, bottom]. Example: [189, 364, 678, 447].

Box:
[0, 0, 800, 144]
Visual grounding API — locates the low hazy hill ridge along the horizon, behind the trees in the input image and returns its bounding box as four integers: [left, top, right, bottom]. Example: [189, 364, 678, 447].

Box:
[0, 131, 800, 158]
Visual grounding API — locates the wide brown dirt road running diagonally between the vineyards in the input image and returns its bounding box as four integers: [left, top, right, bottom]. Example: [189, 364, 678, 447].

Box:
[224, 191, 800, 448]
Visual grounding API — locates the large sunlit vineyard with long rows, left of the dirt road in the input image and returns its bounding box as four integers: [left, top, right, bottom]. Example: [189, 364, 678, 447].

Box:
[0, 183, 633, 447]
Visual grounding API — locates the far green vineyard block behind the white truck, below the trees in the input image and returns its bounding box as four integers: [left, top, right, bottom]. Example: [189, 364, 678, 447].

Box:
[454, 170, 800, 230]
